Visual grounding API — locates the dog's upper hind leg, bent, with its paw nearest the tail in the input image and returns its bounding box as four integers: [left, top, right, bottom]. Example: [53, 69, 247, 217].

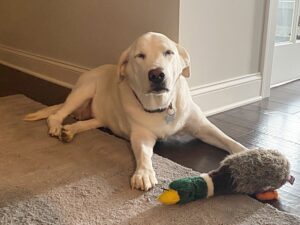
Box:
[47, 84, 95, 137]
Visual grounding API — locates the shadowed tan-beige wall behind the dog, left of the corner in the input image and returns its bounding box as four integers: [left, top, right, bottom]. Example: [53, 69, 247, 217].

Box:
[0, 0, 179, 68]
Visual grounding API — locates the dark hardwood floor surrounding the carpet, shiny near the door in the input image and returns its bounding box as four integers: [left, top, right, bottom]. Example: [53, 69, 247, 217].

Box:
[0, 65, 300, 216]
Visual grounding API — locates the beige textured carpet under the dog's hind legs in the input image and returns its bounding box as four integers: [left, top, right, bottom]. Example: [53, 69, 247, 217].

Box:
[0, 95, 300, 225]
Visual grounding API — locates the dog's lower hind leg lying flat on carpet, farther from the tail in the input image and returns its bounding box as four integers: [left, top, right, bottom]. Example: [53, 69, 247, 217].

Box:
[59, 119, 103, 142]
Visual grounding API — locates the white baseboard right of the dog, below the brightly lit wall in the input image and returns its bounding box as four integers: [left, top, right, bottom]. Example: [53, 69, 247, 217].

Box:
[191, 73, 262, 116]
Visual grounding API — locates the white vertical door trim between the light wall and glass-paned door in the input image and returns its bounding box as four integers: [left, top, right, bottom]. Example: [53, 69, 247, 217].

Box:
[260, 0, 278, 98]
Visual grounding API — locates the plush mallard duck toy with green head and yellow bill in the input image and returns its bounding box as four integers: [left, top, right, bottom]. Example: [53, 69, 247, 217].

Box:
[159, 149, 295, 205]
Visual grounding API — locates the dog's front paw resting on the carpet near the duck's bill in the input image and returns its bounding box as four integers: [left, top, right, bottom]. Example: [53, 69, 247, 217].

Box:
[131, 169, 158, 191]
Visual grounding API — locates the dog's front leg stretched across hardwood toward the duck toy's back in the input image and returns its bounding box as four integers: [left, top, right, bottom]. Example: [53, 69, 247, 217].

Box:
[186, 104, 247, 153]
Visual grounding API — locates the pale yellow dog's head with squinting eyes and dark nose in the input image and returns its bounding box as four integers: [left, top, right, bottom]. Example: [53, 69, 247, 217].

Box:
[118, 32, 190, 109]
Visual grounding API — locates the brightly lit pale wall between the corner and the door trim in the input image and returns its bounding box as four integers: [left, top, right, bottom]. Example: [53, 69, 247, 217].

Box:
[179, 0, 266, 86]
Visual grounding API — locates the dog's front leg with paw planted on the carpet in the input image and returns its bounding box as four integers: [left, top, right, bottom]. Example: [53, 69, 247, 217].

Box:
[130, 129, 157, 191]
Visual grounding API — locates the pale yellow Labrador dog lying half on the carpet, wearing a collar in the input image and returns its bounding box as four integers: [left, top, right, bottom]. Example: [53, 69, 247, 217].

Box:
[25, 32, 246, 191]
